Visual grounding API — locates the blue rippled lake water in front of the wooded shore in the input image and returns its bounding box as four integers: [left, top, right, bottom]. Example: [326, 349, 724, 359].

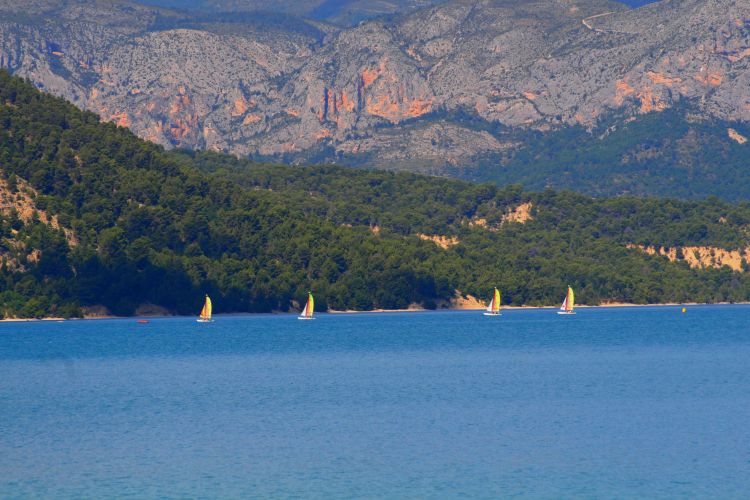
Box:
[0, 306, 750, 498]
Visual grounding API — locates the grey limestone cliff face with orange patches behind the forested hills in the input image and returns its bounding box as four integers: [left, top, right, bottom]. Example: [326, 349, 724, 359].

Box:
[0, 0, 750, 166]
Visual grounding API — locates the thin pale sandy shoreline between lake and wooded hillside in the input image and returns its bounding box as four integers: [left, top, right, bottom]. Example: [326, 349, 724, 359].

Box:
[0, 302, 750, 323]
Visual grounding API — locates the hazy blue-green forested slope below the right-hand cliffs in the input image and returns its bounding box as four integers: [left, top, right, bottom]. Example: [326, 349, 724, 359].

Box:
[482, 106, 750, 201]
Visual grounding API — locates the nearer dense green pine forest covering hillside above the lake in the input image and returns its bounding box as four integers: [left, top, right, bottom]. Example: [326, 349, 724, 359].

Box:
[0, 72, 750, 317]
